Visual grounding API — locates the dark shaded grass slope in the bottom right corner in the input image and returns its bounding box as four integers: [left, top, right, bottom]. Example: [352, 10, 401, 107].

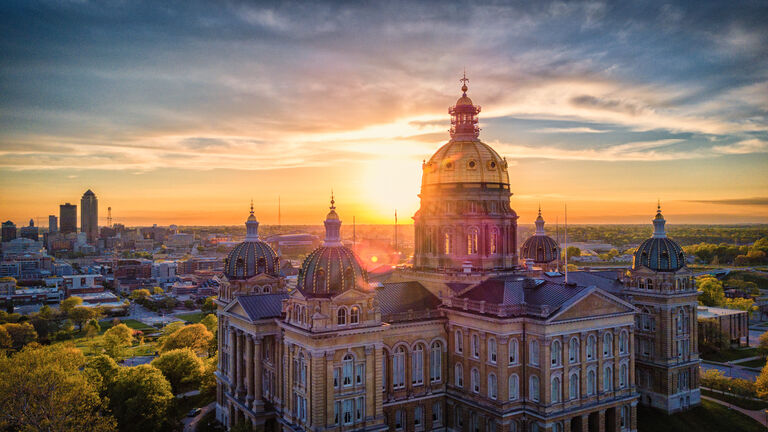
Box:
[637, 400, 765, 432]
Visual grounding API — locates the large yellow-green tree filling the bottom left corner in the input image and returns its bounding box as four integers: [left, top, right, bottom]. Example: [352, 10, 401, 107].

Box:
[0, 344, 116, 432]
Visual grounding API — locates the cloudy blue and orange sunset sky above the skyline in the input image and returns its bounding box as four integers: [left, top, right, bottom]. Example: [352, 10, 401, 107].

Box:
[0, 0, 768, 226]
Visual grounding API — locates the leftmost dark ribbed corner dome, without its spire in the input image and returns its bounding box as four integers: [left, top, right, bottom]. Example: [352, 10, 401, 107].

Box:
[224, 241, 280, 279]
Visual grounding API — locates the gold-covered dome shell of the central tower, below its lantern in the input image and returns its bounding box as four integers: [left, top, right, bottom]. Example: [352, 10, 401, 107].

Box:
[421, 140, 509, 187]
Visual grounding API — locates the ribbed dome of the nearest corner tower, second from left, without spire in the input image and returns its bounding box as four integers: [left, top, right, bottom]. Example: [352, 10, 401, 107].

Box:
[297, 246, 368, 297]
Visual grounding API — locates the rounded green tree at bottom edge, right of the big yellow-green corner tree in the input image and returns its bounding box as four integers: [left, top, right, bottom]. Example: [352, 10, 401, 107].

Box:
[109, 365, 175, 432]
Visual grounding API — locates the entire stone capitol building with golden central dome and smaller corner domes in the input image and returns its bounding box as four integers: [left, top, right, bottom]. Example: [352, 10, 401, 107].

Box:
[216, 79, 700, 432]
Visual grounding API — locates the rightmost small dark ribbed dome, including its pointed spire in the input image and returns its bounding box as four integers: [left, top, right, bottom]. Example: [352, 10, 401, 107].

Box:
[632, 205, 685, 272]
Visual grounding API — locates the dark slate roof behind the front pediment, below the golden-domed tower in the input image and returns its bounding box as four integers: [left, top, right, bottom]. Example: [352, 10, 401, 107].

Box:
[459, 275, 587, 311]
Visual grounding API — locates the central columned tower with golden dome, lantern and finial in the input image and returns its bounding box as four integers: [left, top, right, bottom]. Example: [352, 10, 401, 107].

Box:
[413, 75, 517, 272]
